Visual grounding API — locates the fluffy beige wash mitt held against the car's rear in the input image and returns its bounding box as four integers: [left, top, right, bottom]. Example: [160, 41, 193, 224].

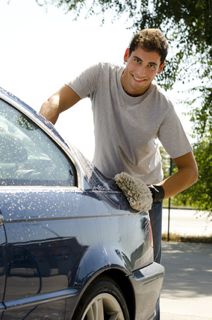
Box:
[114, 172, 153, 211]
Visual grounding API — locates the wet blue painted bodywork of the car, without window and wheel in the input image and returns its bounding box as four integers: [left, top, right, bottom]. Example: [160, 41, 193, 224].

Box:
[0, 89, 164, 320]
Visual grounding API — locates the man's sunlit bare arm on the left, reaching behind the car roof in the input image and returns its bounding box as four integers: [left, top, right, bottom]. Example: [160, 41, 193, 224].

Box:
[40, 86, 80, 124]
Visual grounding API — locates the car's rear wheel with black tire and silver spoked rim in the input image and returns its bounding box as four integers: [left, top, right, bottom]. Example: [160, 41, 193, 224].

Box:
[73, 277, 130, 320]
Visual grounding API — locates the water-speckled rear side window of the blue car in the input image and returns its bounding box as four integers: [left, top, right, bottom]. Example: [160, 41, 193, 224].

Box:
[0, 100, 76, 186]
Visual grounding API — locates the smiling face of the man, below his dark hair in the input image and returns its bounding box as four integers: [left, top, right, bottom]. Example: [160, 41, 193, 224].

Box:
[121, 48, 164, 96]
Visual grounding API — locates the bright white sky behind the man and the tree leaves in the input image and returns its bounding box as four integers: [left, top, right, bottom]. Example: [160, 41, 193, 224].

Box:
[0, 0, 190, 160]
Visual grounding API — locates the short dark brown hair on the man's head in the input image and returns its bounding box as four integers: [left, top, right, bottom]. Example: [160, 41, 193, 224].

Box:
[129, 28, 168, 63]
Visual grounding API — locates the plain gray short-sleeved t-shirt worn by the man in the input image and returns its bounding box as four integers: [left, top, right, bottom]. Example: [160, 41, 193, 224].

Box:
[68, 63, 192, 184]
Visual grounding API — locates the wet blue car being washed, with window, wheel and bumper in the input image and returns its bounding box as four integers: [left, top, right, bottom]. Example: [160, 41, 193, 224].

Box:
[0, 89, 164, 320]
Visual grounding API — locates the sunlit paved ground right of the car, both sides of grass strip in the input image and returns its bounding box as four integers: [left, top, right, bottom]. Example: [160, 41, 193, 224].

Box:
[160, 211, 212, 320]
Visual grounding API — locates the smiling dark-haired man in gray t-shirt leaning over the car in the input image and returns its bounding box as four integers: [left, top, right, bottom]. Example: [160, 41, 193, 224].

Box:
[40, 29, 198, 319]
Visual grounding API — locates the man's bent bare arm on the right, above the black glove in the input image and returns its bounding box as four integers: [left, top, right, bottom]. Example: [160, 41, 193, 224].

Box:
[161, 152, 198, 198]
